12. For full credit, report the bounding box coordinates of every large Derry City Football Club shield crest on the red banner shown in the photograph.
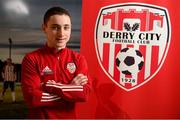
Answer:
[94,3,171,91]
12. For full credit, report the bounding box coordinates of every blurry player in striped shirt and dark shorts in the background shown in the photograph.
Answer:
[1,58,16,102]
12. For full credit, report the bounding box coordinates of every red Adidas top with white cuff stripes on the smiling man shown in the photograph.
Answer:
[22,45,91,119]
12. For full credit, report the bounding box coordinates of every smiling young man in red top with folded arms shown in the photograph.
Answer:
[22,7,91,119]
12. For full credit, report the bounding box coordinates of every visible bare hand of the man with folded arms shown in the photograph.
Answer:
[70,74,88,86]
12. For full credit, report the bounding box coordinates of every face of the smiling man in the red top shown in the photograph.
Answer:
[43,15,71,50]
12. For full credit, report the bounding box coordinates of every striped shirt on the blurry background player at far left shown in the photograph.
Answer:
[2,65,16,81]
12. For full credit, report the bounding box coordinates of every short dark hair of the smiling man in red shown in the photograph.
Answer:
[43,7,71,25]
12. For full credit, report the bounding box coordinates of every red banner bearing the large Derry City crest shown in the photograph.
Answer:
[77,0,180,118]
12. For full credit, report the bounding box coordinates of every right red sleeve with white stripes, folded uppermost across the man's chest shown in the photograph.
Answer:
[43,57,92,101]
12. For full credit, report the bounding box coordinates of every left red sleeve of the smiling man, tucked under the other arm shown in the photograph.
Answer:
[21,56,61,107]
